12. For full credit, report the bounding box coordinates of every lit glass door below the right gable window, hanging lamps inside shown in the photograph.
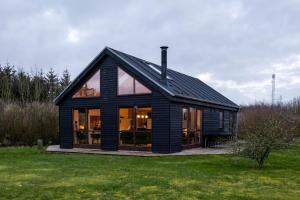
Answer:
[119,107,152,148]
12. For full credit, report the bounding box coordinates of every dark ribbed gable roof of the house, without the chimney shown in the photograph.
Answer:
[54,47,239,109]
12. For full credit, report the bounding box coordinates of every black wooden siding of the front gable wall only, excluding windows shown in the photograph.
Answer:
[59,57,170,153]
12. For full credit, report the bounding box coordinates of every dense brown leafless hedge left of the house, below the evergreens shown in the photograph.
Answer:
[0,102,58,146]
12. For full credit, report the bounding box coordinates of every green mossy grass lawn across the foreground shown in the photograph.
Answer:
[0,139,300,199]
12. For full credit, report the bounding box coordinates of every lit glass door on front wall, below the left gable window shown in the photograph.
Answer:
[73,108,101,144]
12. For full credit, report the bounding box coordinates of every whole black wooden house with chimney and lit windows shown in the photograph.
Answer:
[55,47,239,153]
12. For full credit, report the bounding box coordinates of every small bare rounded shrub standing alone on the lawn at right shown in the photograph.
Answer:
[238,106,292,168]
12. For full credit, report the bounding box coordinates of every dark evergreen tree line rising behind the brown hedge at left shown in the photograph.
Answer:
[0,63,71,103]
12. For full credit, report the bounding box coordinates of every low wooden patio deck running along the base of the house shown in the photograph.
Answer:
[46,145,232,157]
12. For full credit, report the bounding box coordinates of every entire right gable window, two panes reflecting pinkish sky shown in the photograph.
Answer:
[118,67,151,95]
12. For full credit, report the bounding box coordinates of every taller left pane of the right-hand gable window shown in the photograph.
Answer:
[118,68,134,95]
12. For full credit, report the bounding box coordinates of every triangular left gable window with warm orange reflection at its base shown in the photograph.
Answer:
[73,70,100,98]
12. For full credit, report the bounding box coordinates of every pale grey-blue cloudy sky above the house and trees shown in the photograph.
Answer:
[0,0,300,104]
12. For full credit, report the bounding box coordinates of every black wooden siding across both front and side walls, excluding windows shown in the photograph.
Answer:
[59,56,236,153]
